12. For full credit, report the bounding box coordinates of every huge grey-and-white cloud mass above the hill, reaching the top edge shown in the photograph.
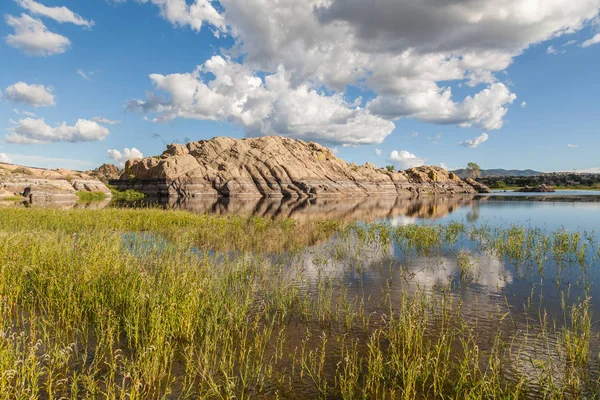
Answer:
[128,0,599,144]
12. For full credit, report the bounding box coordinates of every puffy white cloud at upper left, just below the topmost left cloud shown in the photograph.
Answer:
[5,14,71,56]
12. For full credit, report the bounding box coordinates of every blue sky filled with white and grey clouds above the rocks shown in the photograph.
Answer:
[0,0,600,173]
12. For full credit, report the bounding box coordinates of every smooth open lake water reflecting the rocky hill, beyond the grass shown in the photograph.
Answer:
[112,191,600,231]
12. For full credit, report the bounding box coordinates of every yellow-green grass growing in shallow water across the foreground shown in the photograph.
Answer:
[0,209,600,399]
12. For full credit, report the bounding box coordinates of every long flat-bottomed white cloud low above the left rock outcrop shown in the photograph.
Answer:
[4,118,110,144]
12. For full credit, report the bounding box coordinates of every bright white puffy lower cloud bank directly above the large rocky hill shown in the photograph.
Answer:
[127,56,395,145]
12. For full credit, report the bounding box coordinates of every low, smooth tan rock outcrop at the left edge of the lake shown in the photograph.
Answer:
[0,163,111,203]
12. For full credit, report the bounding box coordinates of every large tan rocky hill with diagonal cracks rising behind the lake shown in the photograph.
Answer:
[110,136,488,197]
